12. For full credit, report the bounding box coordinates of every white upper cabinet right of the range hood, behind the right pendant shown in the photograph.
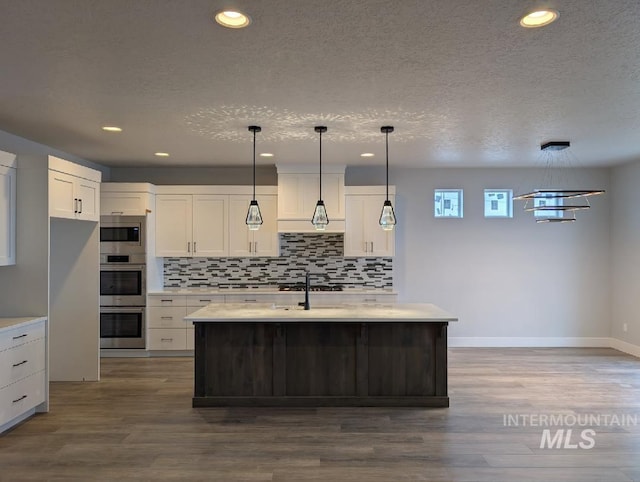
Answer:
[344,186,395,257]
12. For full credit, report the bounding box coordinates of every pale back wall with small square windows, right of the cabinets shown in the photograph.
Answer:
[347,168,611,338]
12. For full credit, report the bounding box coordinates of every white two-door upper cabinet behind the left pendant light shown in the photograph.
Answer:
[229,195,279,257]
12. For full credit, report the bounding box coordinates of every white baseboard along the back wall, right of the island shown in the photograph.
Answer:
[448,336,612,348]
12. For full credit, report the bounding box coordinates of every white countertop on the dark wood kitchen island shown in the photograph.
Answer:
[185,303,458,323]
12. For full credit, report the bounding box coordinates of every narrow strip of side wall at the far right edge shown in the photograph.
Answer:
[611,163,640,347]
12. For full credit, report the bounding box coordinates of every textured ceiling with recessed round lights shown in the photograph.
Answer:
[0,0,640,167]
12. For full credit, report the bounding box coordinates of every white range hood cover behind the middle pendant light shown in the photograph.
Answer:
[278,165,345,233]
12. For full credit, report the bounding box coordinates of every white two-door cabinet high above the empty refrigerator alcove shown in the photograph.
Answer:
[49,156,102,221]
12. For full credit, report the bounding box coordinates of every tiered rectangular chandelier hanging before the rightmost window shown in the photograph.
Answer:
[513,141,604,223]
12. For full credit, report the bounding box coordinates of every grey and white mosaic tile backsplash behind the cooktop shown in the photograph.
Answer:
[164,233,393,288]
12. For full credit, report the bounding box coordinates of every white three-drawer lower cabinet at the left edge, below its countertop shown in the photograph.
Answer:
[0,320,47,432]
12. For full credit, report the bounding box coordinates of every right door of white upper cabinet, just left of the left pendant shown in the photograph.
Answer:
[192,194,229,257]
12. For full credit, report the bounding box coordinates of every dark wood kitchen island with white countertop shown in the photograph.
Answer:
[185,303,457,407]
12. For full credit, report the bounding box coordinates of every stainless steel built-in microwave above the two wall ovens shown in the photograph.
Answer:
[100,216,147,254]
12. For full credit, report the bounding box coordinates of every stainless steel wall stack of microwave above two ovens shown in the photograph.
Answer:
[100,216,147,348]
